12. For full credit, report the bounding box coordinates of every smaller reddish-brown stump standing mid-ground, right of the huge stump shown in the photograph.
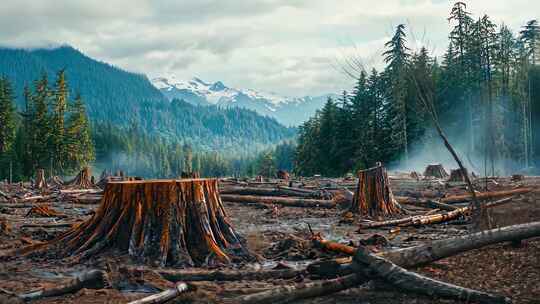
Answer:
[350,163,402,217]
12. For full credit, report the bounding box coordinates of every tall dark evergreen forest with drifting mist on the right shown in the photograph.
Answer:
[295,2,540,176]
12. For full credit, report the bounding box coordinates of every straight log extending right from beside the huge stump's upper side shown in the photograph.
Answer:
[221,194,336,208]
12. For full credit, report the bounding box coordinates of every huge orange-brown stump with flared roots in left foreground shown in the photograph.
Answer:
[22,179,252,266]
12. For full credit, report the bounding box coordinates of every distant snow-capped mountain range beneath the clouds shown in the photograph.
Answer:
[152,77,333,126]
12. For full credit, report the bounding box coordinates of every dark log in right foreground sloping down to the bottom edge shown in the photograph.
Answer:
[352,247,511,304]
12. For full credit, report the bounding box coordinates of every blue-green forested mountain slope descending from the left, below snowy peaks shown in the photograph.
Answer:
[0,46,294,151]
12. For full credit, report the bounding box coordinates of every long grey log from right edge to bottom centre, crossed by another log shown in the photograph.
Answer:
[249,222,540,304]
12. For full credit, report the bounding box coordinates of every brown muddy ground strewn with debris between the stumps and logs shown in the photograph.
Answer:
[0,178,540,304]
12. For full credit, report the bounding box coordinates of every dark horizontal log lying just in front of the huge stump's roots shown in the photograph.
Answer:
[154,268,306,282]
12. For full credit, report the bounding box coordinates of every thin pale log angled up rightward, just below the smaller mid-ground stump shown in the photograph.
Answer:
[360,197,513,229]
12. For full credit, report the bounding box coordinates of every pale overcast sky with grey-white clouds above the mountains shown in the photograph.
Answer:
[0,0,540,96]
